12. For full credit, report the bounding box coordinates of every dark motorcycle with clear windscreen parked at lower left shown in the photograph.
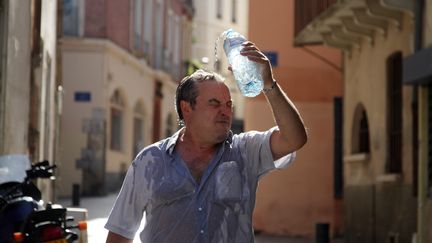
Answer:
[0,155,87,243]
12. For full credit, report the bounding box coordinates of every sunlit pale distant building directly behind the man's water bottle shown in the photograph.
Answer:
[192,0,249,133]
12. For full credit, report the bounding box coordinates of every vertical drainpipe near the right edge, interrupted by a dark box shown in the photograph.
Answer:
[413,0,428,243]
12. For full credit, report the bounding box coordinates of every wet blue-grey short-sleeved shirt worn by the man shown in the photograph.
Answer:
[105,127,295,243]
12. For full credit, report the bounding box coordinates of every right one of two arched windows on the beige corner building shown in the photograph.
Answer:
[132,102,145,156]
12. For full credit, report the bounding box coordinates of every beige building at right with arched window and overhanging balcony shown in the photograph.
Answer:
[295,0,420,242]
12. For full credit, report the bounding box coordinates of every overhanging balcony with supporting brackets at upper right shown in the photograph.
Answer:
[294,0,414,53]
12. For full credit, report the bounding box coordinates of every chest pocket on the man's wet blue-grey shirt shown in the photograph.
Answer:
[215,161,242,203]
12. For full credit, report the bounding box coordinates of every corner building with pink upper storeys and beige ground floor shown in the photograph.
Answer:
[58,0,194,196]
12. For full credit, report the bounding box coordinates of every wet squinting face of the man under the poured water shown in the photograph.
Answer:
[186,80,233,143]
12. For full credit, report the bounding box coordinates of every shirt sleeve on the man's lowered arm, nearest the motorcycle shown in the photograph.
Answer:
[105,161,146,239]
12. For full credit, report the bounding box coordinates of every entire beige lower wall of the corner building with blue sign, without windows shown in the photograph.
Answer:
[58,38,162,196]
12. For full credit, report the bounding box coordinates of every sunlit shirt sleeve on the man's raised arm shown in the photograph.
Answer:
[238,127,296,178]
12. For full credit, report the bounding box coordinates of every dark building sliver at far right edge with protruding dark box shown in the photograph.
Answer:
[403,0,432,243]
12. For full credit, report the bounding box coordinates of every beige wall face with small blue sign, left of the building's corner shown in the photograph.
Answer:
[56,39,104,196]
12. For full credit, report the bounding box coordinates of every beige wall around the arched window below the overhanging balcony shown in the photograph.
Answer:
[344,13,413,185]
